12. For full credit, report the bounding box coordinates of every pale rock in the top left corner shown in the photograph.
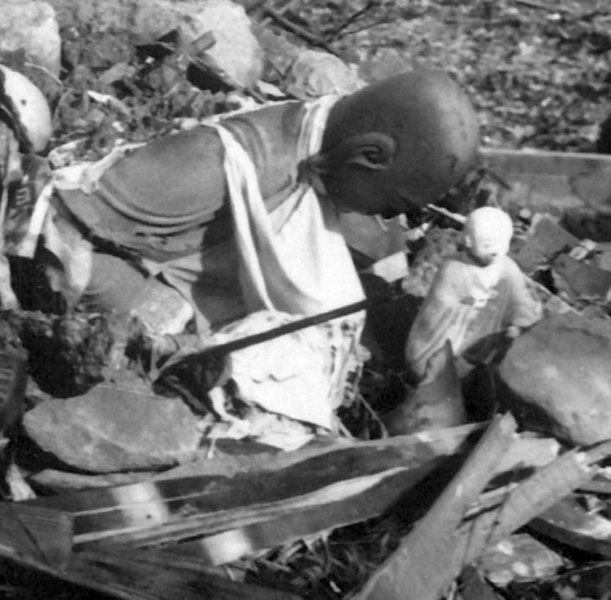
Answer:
[0,0,61,77]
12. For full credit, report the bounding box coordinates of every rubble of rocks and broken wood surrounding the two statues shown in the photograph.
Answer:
[0,0,611,600]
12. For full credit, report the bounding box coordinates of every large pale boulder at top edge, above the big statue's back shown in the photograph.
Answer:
[45,0,263,86]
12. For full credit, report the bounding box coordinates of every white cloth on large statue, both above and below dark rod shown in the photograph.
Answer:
[206,98,364,428]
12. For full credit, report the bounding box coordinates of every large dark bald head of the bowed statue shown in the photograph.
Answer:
[317,71,479,217]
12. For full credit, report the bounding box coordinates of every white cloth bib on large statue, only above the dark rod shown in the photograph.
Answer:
[213,97,364,315]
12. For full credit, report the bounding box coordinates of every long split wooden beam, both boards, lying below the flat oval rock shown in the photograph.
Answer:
[23,426,486,547]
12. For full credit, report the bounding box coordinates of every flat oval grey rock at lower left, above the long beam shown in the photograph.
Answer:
[24,385,201,473]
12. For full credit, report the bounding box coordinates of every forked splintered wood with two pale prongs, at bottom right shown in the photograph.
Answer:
[357,426,611,600]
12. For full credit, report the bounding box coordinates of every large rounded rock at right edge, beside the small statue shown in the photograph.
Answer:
[499,314,611,445]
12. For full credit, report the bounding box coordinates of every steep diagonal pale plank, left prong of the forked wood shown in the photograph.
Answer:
[357,414,517,600]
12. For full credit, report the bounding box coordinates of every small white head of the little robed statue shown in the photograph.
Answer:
[464,206,513,267]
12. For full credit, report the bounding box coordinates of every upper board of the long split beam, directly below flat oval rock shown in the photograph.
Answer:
[26,426,480,542]
